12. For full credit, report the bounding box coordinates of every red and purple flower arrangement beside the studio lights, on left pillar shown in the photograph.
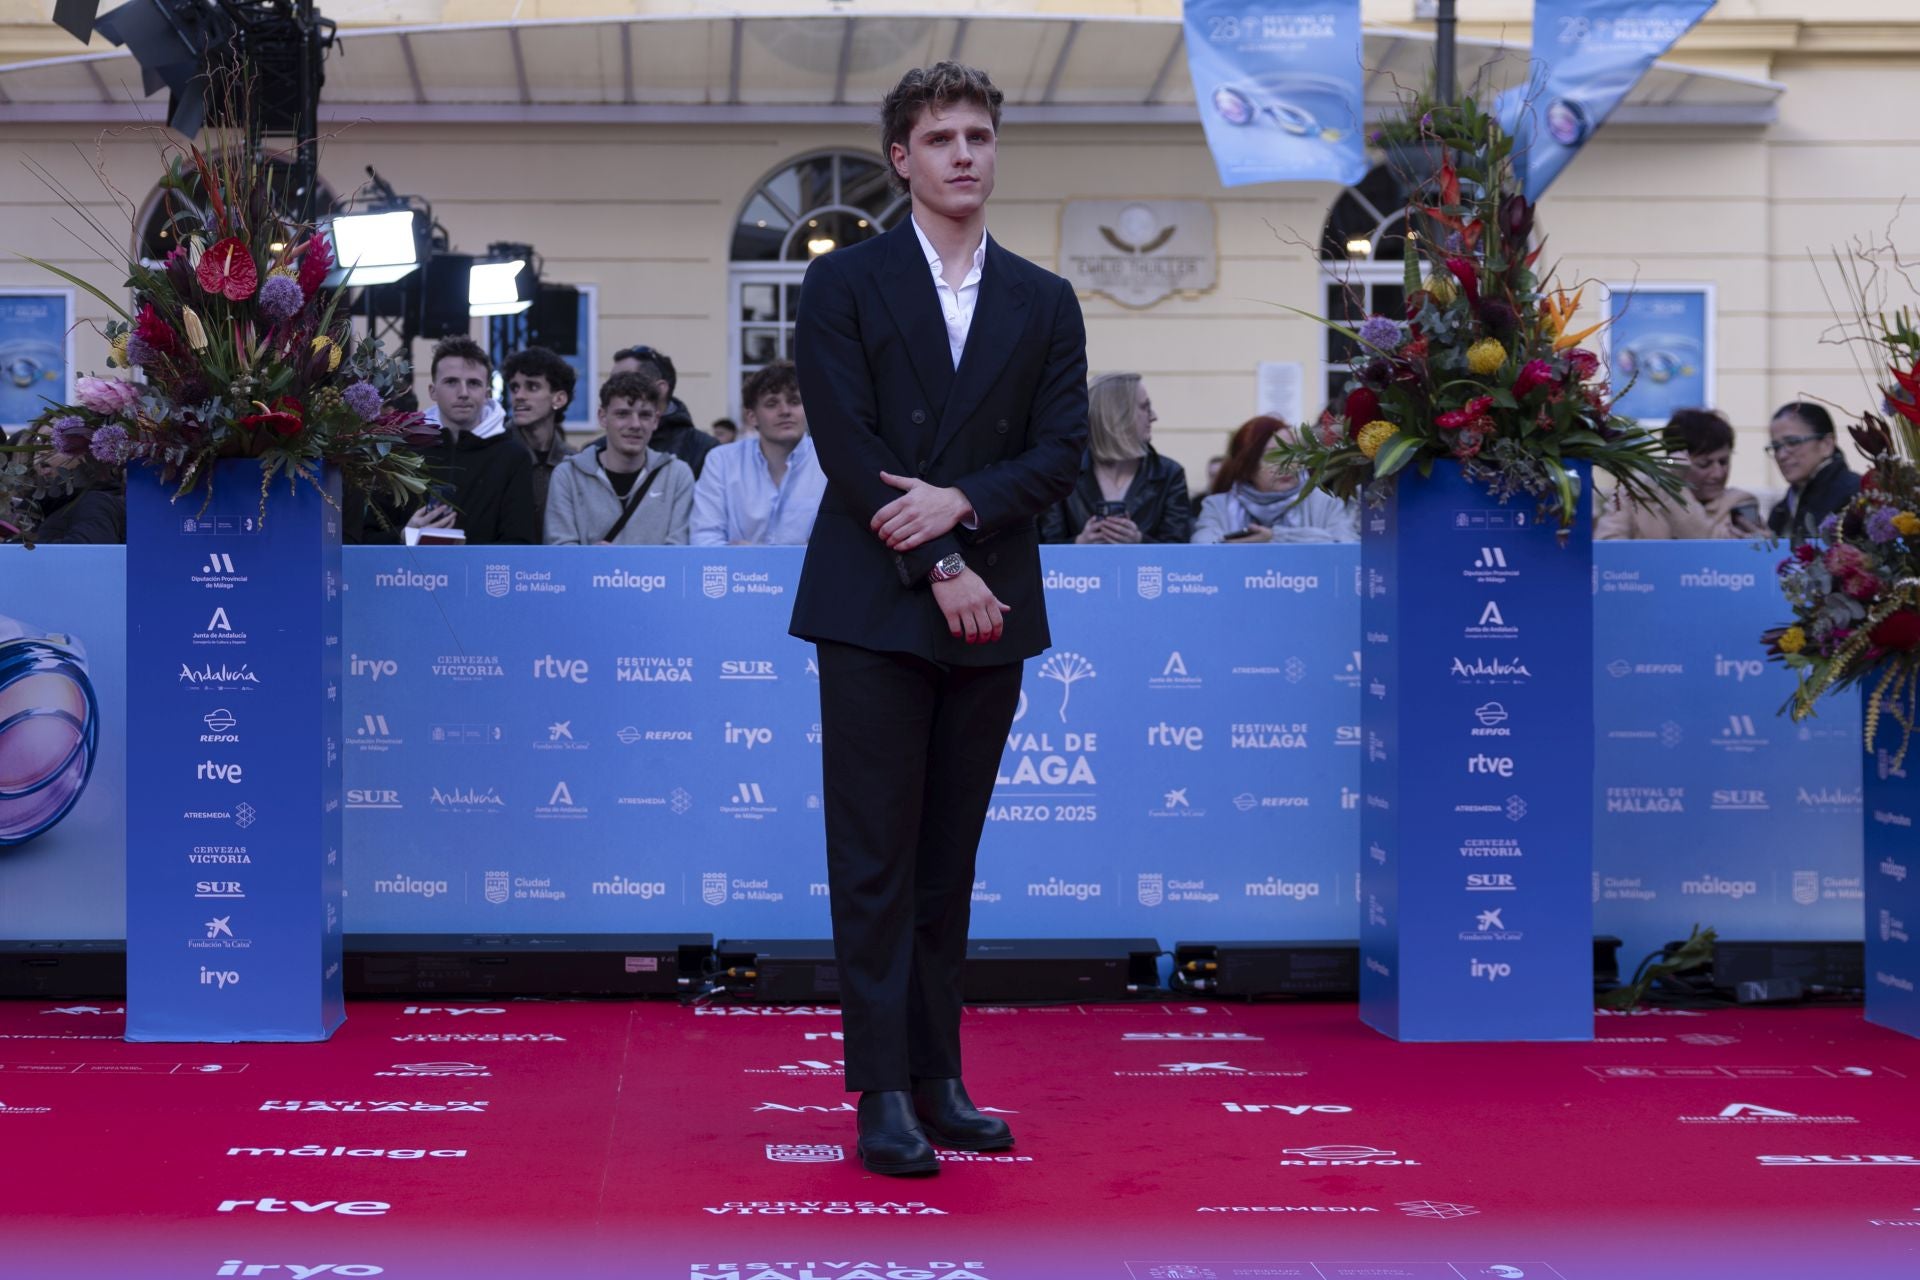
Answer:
[0,131,436,520]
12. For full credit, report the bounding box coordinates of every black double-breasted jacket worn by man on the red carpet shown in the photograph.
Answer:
[791,219,1087,666]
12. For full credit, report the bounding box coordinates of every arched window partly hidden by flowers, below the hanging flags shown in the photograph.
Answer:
[1308,165,1407,413]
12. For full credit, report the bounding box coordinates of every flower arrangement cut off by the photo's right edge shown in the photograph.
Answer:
[1761,289,1920,768]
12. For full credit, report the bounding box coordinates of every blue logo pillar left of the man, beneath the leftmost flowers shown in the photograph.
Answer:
[127,461,346,1042]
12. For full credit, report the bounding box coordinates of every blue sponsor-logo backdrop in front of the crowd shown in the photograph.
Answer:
[0,543,1862,961]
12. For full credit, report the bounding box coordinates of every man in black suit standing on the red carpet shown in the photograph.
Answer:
[791,61,1087,1174]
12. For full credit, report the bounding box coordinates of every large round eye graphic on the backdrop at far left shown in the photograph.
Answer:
[0,616,100,846]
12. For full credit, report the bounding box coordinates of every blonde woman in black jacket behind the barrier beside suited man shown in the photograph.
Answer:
[1041,374,1194,543]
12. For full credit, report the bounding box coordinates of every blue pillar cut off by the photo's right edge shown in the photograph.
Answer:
[1860,736,1920,1036]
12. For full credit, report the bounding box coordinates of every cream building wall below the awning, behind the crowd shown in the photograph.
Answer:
[11,45,1920,489]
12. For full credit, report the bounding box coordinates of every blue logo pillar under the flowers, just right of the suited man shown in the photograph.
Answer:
[1359,462,1594,1040]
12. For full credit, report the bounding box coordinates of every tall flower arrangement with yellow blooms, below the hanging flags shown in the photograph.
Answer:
[1275,98,1680,532]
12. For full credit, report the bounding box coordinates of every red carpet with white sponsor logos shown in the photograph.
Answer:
[0,1000,1920,1280]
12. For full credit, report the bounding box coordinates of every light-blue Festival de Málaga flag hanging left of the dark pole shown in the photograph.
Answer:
[1185,0,1367,186]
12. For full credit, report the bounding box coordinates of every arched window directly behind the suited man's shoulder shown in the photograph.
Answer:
[728,152,908,416]
